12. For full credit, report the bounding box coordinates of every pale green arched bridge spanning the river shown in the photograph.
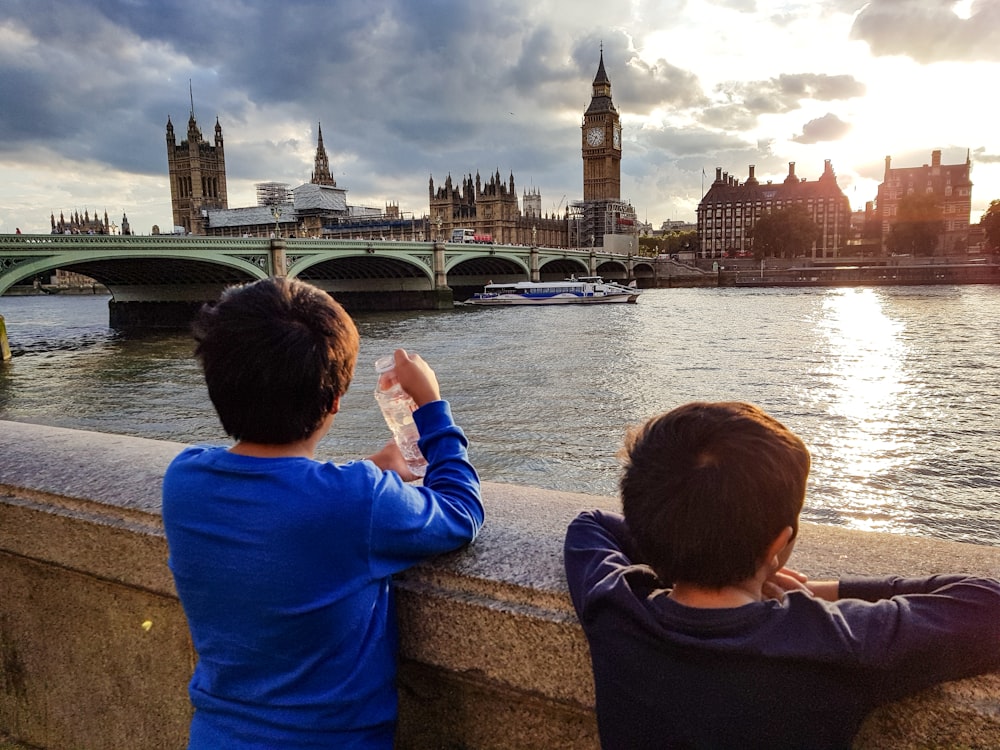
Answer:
[0,234,655,328]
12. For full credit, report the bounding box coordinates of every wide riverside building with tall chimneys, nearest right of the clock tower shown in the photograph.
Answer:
[698,159,851,258]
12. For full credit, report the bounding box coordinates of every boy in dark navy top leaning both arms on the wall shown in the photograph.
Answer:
[565,403,1000,750]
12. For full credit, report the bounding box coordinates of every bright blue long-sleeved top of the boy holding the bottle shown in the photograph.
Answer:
[163,401,483,750]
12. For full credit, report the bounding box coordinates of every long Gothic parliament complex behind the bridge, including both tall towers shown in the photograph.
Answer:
[166,50,638,252]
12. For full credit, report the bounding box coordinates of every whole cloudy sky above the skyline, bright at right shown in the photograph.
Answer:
[0,0,1000,234]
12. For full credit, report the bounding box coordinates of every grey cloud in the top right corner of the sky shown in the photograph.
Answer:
[851,0,1000,63]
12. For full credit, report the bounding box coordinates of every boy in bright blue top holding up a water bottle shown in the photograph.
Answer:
[163,278,483,750]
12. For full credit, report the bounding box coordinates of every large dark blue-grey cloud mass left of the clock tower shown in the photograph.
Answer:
[0,0,584,187]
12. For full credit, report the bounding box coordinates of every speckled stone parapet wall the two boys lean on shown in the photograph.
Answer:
[0,422,1000,750]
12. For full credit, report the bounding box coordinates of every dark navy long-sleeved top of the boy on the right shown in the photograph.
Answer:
[565,511,1000,750]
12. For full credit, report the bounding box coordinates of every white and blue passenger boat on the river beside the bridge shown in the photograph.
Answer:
[465,276,641,306]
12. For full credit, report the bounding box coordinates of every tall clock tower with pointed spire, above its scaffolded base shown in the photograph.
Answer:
[582,50,622,201]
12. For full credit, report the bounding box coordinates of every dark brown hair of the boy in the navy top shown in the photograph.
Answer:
[619,402,810,589]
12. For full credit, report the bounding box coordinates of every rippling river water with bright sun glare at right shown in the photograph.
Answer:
[0,286,1000,546]
